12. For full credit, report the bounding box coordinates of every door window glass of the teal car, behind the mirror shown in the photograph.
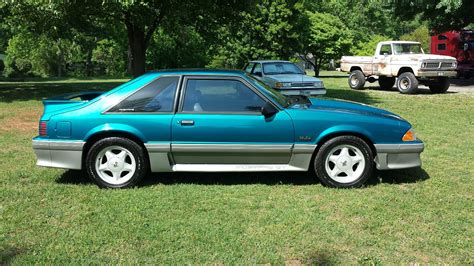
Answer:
[183,79,265,113]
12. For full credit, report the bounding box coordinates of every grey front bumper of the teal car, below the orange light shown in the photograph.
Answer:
[374,142,425,170]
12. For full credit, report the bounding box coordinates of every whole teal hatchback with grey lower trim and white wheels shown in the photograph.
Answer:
[33,70,424,188]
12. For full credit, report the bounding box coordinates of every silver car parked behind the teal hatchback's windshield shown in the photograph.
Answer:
[244,60,326,96]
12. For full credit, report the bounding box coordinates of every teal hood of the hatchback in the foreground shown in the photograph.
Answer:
[292,98,406,121]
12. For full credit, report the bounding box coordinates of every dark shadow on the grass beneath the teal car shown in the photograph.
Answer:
[56,168,430,187]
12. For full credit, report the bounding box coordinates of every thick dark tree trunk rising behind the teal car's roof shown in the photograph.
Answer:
[127,24,147,77]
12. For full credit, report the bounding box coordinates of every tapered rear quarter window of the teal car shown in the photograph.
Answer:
[109,77,179,113]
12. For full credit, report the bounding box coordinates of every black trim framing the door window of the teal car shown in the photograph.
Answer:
[176,75,281,115]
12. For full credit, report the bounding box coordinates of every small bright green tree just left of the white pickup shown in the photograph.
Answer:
[300,11,353,76]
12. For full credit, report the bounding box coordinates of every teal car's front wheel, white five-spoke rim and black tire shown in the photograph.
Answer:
[314,136,374,188]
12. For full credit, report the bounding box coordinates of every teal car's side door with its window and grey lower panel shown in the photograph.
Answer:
[171,76,294,164]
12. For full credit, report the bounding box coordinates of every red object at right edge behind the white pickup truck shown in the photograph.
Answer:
[431,30,474,78]
